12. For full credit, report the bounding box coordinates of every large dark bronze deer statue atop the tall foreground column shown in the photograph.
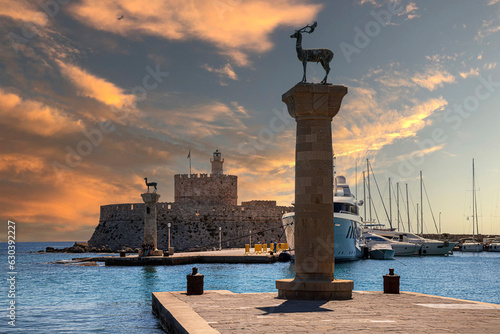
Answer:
[290,22,333,84]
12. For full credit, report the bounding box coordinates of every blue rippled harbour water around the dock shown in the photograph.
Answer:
[0,243,500,333]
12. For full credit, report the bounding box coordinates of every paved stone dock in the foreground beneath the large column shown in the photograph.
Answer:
[152,290,500,334]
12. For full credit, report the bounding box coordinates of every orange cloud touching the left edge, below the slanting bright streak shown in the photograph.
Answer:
[0,88,83,136]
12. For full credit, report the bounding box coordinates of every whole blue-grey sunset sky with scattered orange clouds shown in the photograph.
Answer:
[0,0,500,241]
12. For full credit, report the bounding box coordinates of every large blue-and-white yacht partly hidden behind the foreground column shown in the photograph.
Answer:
[282,176,363,262]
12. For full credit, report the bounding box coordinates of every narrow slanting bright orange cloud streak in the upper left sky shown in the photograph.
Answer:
[56,60,135,108]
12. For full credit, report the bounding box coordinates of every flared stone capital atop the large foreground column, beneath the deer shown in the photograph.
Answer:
[281,83,347,119]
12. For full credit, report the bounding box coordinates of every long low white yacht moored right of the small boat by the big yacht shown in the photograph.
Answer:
[370,230,457,255]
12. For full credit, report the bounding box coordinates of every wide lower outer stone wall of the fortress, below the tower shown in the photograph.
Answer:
[88,201,293,251]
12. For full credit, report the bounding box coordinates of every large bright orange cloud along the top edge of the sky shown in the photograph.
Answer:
[71,0,322,66]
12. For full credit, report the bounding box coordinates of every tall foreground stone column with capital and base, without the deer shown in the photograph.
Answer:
[276,84,354,300]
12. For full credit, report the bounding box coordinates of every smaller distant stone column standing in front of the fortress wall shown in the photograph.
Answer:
[139,193,163,256]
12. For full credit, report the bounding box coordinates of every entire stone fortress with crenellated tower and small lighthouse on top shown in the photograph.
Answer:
[88,150,293,251]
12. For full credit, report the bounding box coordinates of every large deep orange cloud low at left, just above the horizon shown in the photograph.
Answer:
[0,154,146,241]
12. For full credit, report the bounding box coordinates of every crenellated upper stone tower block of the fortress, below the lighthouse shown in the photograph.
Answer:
[174,174,238,205]
